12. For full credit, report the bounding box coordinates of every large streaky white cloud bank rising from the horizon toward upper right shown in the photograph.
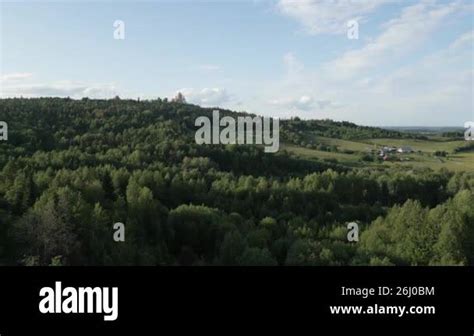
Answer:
[254,1,474,126]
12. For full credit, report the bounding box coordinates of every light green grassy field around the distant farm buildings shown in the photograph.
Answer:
[282,137,474,171]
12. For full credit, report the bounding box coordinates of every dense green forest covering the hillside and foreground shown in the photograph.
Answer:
[0,98,474,265]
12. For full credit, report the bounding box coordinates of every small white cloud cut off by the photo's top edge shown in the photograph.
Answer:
[277,0,387,34]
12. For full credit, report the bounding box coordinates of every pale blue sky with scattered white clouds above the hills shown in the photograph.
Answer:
[0,0,474,126]
